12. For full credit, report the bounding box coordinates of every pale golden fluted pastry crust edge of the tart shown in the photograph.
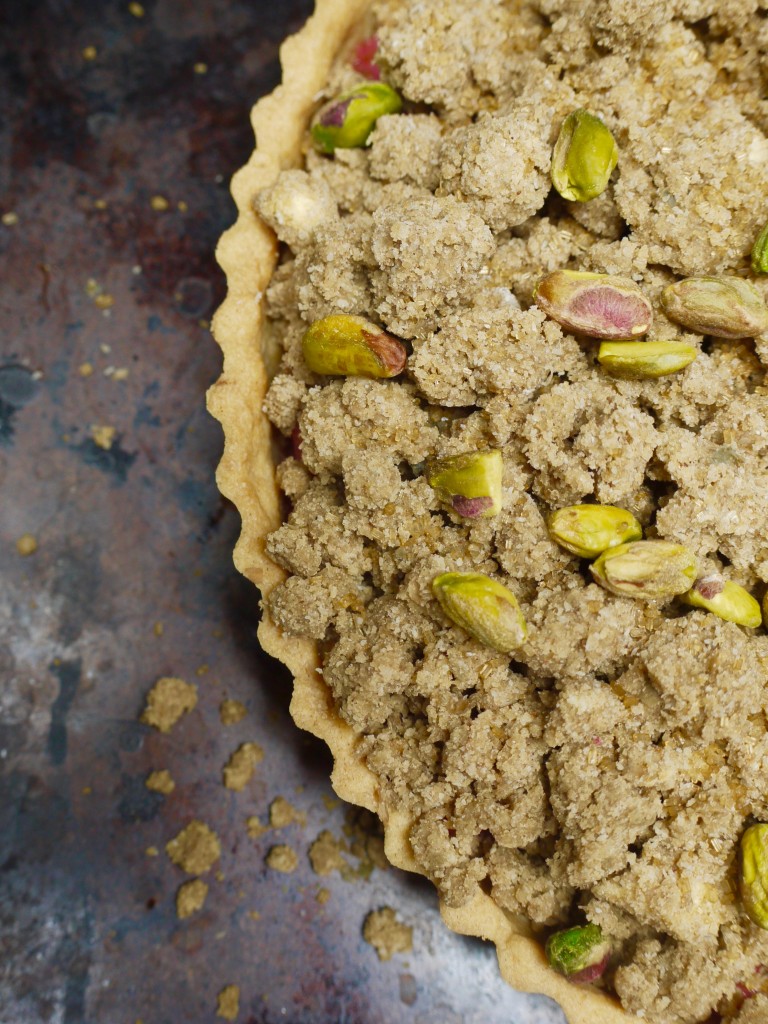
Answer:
[208,0,637,1024]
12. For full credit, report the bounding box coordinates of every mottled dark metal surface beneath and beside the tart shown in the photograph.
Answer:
[0,8,563,1024]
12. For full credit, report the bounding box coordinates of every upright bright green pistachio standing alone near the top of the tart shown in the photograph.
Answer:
[551,109,618,203]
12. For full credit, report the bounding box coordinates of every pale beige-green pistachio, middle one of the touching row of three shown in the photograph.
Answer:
[590,541,696,601]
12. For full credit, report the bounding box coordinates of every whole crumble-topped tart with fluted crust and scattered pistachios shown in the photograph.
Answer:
[209,0,768,1024]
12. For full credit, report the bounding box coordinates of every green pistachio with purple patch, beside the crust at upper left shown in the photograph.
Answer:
[311,82,402,153]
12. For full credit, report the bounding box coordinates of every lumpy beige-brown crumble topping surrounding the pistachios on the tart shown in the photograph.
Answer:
[256,0,768,1024]
